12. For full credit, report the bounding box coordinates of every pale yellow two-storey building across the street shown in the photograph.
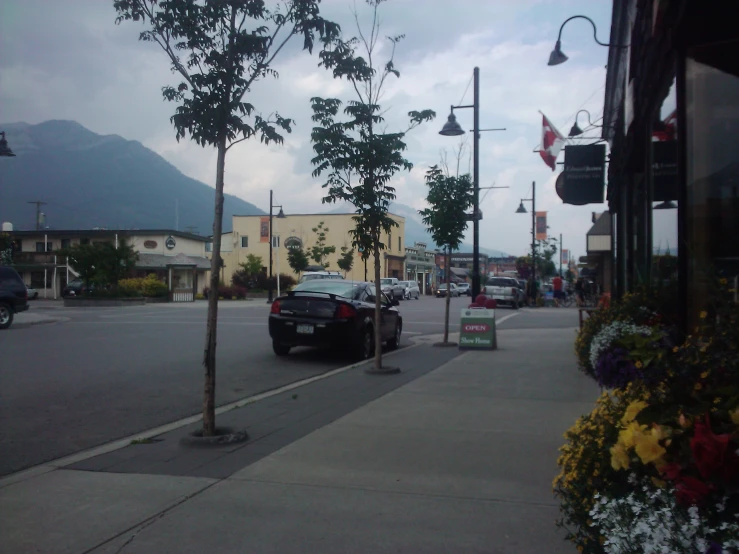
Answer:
[211,209,405,284]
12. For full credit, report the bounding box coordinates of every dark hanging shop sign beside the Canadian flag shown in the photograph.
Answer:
[555,144,606,206]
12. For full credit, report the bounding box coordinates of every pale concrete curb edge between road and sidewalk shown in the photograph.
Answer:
[0,342,424,489]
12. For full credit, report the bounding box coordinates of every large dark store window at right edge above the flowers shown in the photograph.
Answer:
[685,41,739,324]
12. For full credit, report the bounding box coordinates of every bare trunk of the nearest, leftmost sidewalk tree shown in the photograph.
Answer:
[203,134,226,437]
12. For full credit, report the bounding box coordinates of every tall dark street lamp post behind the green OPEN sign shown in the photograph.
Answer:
[439,67,505,298]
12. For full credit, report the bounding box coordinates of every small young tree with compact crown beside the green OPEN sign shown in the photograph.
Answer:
[418,166,474,345]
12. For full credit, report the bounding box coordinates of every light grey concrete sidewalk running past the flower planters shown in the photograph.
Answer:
[0,329,598,554]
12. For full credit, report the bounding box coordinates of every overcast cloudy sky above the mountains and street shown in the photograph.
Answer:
[0,0,636,256]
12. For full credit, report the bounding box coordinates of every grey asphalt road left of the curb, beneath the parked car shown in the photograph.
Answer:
[0,297,577,475]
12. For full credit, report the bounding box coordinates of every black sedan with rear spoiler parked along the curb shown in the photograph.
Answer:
[269,279,403,360]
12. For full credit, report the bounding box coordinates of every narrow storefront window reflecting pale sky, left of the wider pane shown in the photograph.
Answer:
[651,78,679,294]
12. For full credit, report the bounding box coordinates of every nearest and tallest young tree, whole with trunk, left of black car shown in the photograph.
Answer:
[113,0,339,436]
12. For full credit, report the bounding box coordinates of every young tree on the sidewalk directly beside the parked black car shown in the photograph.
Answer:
[311,0,436,372]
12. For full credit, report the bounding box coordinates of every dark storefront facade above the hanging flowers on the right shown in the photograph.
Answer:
[603,0,739,328]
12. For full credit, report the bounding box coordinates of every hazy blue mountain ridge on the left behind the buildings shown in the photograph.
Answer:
[0,121,264,235]
